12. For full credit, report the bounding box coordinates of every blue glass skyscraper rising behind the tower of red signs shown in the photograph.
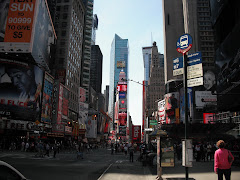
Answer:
[108,34,129,126]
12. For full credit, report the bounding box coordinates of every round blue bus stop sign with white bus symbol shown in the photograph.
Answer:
[177,34,192,54]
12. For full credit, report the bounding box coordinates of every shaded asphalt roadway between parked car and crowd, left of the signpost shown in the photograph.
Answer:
[0,149,154,180]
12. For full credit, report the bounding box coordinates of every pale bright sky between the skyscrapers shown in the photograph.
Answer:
[93,0,164,125]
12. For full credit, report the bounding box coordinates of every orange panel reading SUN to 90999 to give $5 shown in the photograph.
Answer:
[1,0,36,43]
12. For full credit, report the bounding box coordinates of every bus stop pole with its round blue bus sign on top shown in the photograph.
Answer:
[177,34,192,180]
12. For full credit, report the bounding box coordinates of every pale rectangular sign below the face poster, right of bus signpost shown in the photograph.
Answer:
[195,91,217,108]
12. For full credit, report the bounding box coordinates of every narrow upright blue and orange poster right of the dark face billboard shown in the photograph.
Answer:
[41,72,54,123]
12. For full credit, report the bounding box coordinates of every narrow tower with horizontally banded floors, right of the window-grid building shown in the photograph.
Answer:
[81,0,94,101]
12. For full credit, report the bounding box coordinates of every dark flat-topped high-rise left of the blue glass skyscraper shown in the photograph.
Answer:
[90,45,103,93]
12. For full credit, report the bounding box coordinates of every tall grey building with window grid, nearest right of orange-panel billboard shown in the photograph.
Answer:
[50,0,85,118]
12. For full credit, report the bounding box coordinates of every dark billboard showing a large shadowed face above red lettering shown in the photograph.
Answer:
[0,59,43,121]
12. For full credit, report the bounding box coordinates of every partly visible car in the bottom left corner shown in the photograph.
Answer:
[0,161,27,180]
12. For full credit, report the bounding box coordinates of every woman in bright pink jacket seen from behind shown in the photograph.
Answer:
[214,140,234,180]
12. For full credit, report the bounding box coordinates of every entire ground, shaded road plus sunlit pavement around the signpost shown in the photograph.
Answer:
[0,148,240,180]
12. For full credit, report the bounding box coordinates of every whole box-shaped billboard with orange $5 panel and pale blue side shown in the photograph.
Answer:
[0,0,56,69]
